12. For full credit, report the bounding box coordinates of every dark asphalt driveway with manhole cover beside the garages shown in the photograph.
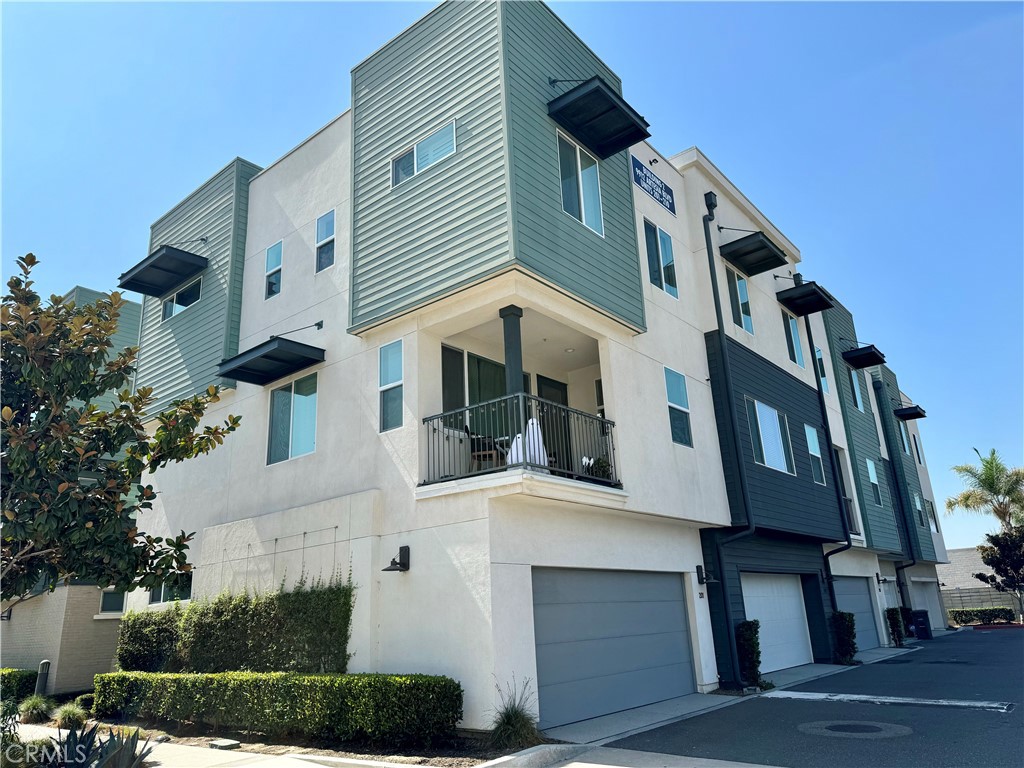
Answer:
[607,630,1024,768]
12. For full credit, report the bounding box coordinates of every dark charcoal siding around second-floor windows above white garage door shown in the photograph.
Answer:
[705,332,843,541]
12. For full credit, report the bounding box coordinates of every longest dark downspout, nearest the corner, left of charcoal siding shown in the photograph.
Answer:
[703,191,756,684]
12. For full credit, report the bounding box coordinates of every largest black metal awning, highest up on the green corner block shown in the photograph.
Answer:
[548,77,650,160]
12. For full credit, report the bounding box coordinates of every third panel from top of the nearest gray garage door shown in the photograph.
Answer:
[537,632,689,684]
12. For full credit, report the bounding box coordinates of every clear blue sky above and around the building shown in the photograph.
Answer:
[2,2,1024,547]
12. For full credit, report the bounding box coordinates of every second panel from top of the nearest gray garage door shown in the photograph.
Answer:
[534,602,686,643]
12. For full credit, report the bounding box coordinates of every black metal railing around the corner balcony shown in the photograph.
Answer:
[423,394,622,487]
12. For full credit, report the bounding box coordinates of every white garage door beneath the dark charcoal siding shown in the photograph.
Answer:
[740,573,814,673]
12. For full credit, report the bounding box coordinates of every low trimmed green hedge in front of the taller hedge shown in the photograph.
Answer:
[94,672,462,746]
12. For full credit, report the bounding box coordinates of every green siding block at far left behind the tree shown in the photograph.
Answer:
[135,159,260,414]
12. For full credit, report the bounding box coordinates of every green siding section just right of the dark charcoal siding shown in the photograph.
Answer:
[822,302,902,553]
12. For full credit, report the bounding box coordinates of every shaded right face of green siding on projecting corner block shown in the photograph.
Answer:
[501,2,643,329]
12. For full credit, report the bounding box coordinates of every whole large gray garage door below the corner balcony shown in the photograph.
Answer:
[534,568,696,728]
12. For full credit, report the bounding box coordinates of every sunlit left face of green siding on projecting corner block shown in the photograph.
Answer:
[351,2,510,331]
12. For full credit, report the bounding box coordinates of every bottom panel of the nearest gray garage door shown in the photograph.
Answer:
[538,664,693,728]
